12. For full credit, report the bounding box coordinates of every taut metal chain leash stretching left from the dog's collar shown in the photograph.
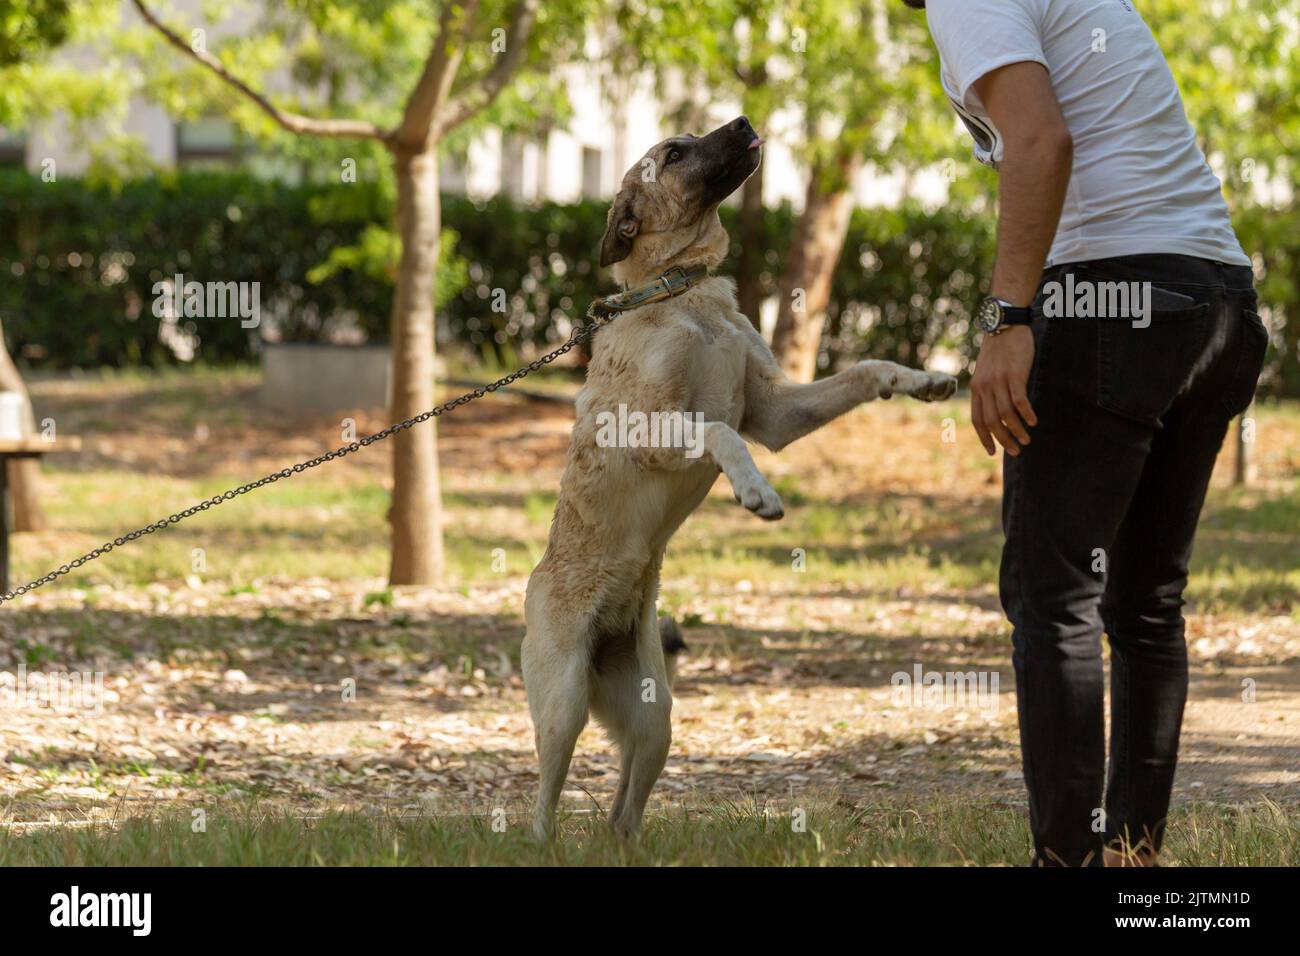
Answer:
[0,311,618,605]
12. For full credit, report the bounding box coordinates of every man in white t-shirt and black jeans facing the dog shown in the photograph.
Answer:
[905,0,1268,866]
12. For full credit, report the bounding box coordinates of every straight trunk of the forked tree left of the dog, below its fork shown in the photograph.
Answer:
[389,147,443,584]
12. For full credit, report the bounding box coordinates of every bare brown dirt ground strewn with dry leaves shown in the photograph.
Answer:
[0,385,1300,822]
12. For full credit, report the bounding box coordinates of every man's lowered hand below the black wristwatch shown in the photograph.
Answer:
[971,325,1039,455]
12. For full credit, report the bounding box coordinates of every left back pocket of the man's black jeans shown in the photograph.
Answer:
[1097,302,1210,425]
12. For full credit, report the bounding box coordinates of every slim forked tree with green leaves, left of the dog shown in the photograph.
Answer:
[125,0,581,584]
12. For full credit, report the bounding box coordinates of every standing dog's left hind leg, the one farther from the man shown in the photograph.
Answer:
[521,633,590,839]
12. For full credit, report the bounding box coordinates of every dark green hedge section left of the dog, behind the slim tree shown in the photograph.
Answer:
[0,172,610,368]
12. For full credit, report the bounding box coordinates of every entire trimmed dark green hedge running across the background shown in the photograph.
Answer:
[0,170,1300,394]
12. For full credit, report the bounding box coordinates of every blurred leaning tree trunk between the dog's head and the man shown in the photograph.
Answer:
[772,159,854,381]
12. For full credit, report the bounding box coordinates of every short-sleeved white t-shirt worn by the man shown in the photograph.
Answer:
[926,0,1251,265]
